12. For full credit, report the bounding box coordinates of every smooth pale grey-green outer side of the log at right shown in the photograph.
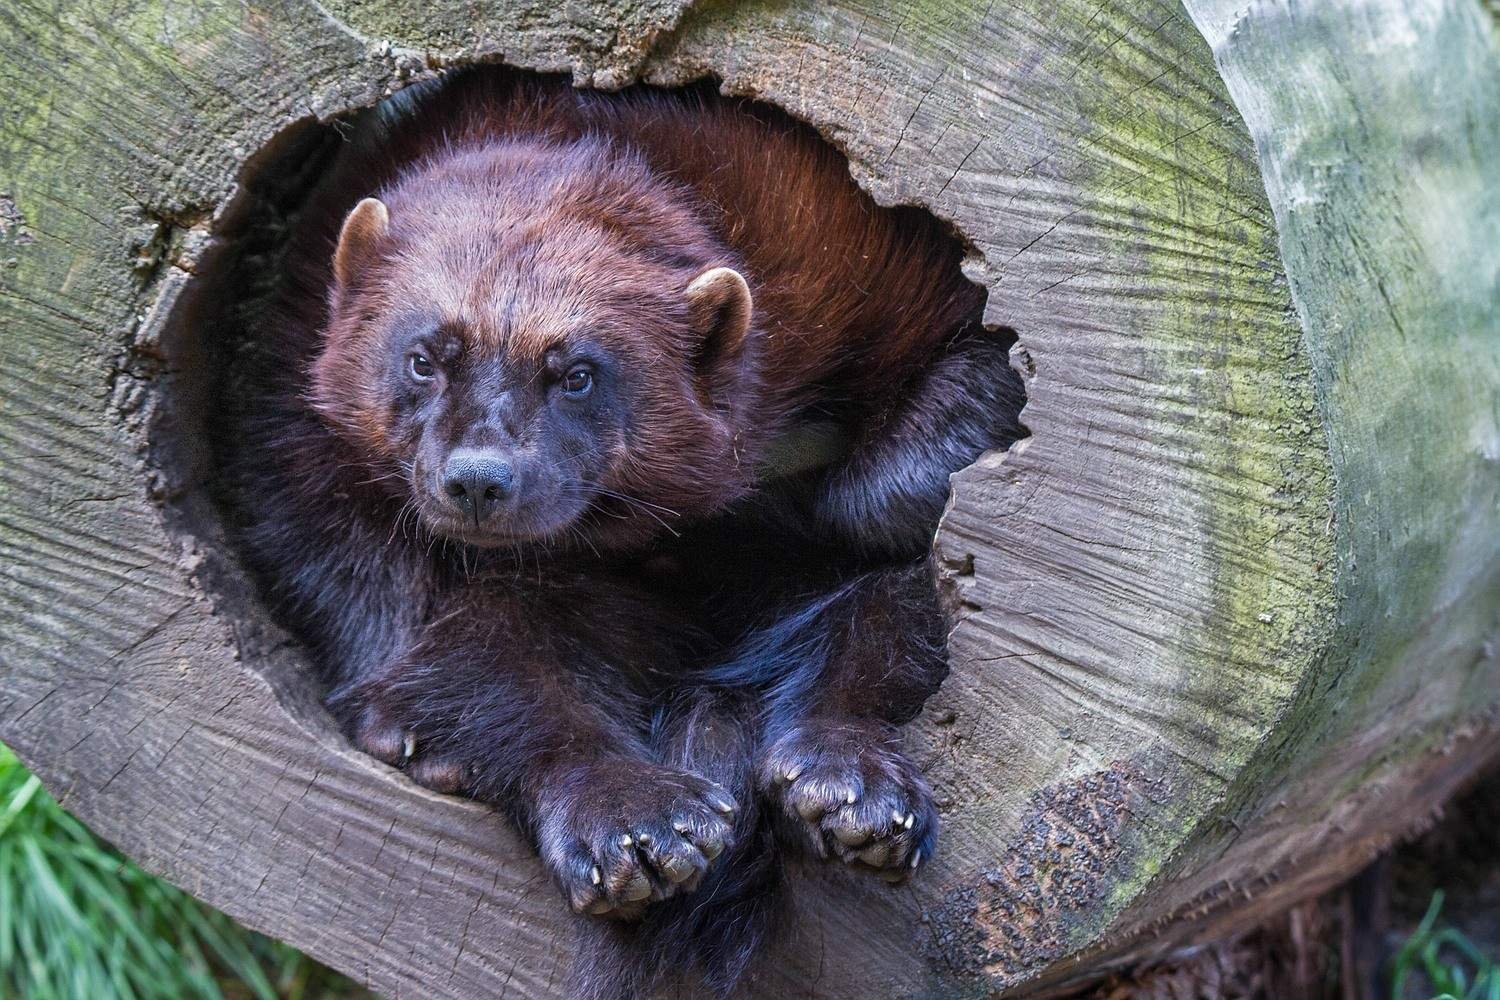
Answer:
[1188,0,1500,803]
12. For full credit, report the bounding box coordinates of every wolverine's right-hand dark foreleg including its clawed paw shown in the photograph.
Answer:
[723,561,947,880]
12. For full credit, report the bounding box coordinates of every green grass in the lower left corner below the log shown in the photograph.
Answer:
[0,747,369,1000]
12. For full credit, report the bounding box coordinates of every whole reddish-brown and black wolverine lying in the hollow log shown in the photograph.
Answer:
[221,69,1022,999]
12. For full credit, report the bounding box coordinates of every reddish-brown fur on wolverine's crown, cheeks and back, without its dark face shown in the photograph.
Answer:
[312,75,981,544]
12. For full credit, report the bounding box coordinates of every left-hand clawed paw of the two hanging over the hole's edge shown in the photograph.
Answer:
[539,760,740,919]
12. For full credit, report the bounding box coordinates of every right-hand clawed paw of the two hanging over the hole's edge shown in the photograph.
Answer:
[759,718,938,883]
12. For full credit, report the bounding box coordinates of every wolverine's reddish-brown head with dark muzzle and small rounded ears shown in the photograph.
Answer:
[311,141,755,547]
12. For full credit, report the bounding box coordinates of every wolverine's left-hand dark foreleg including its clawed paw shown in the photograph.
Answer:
[333,580,738,918]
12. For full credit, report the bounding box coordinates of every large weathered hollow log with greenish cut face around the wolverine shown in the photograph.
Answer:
[0,0,1500,999]
